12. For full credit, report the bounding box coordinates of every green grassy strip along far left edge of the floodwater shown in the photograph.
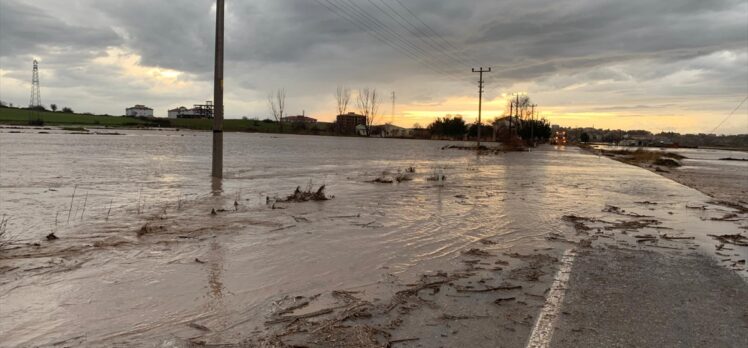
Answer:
[0,108,331,134]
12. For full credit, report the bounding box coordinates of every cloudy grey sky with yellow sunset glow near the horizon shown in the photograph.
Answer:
[0,0,748,133]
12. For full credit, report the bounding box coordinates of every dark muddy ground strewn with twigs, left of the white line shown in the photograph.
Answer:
[240,248,558,348]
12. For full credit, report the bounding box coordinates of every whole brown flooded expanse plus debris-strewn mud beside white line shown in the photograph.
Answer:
[0,130,748,347]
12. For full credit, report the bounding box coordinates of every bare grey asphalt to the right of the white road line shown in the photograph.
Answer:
[551,249,748,347]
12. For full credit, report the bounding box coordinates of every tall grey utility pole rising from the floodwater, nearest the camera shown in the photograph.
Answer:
[212,0,224,179]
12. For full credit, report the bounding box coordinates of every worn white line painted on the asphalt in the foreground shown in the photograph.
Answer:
[527,249,577,348]
